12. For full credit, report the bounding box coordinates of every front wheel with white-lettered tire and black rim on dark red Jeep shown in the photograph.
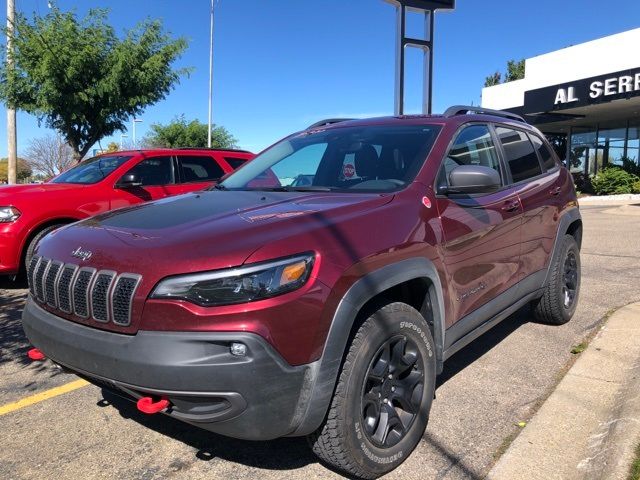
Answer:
[308,303,436,479]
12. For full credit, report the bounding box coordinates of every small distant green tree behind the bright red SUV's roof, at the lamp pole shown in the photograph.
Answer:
[144,115,237,148]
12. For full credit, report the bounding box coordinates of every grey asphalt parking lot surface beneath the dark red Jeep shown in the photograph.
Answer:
[0,206,640,480]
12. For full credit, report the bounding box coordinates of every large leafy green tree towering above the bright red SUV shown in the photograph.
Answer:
[0,8,188,160]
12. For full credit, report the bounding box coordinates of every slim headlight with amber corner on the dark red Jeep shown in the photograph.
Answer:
[151,254,314,307]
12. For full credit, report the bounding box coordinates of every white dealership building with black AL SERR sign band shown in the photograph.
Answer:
[482,28,640,175]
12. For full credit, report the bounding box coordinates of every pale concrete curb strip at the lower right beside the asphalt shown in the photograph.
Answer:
[486,302,640,480]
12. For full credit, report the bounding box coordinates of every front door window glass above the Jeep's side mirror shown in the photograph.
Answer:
[439,125,502,185]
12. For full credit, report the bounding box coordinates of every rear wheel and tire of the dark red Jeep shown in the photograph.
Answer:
[532,235,581,325]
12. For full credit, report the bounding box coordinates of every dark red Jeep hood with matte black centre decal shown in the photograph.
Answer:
[38,191,393,281]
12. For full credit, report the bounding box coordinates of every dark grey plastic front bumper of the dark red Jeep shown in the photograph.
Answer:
[22,298,315,440]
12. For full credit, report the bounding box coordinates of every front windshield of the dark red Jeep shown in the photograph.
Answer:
[217,125,440,192]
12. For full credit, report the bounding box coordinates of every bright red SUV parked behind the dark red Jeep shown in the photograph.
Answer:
[0,149,253,275]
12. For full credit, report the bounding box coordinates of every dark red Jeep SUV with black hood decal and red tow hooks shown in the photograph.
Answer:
[23,107,582,478]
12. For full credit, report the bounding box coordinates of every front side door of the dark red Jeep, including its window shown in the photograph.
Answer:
[436,124,522,327]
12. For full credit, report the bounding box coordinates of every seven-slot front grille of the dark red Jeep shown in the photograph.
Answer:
[27,256,142,327]
